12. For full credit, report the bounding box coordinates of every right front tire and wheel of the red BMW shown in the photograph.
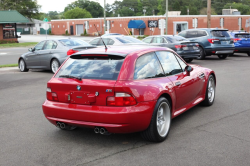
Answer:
[201,75,216,106]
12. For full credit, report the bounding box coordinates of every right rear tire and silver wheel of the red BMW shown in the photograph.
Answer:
[141,97,172,142]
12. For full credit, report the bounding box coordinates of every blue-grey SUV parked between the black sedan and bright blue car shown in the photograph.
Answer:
[178,28,234,59]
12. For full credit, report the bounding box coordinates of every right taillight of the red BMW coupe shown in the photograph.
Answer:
[107,93,136,106]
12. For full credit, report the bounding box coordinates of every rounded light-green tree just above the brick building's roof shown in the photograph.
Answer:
[64,7,92,19]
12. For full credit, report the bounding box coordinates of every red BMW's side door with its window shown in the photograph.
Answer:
[156,51,200,111]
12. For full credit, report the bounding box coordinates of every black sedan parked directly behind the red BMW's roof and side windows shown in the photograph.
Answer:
[143,35,200,62]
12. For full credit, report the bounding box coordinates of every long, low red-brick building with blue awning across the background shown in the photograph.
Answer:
[51,15,250,35]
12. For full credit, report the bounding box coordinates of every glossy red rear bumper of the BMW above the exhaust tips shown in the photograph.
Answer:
[42,100,156,133]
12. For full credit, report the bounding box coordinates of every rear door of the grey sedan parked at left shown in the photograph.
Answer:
[39,40,57,69]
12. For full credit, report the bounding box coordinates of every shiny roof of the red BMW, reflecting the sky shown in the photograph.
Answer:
[74,45,170,57]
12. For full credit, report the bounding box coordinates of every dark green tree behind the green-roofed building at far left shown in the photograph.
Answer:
[0,0,41,18]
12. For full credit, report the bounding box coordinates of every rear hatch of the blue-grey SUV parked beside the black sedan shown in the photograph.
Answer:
[208,29,234,47]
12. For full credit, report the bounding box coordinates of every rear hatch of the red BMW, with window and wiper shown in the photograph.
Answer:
[47,54,124,106]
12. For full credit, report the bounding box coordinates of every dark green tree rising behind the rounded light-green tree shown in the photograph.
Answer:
[64,0,104,18]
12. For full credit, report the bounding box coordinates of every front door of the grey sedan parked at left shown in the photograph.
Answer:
[25,41,46,68]
